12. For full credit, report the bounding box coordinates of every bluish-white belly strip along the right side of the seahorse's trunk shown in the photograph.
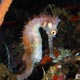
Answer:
[32,27,42,62]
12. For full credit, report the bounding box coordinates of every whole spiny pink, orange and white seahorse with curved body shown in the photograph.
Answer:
[17,15,60,80]
